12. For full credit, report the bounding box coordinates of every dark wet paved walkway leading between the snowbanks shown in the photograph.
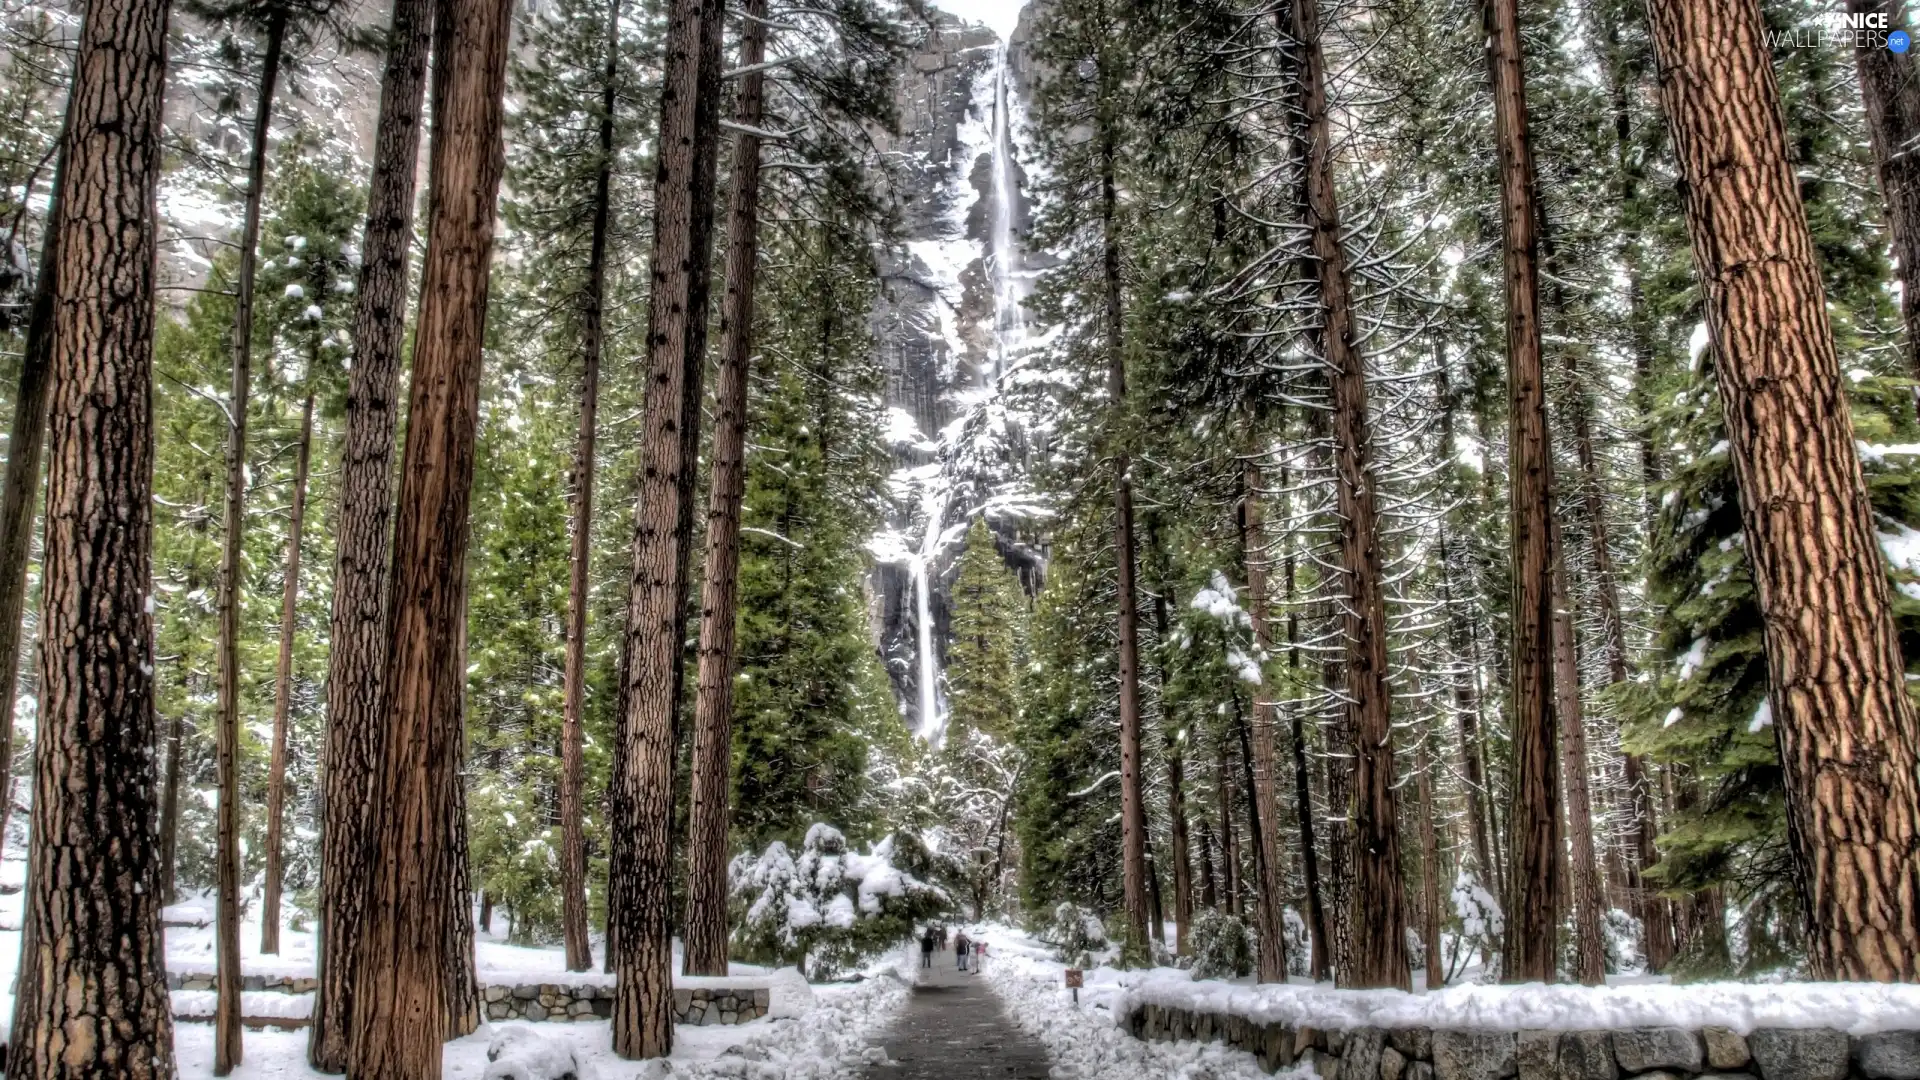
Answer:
[868,951,1046,1080]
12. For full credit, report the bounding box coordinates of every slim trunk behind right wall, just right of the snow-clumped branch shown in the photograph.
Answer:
[1240,457,1286,982]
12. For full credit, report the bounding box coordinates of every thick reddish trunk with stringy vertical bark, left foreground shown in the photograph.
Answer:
[348,0,513,1060]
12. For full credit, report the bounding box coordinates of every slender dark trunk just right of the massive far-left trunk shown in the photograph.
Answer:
[213,18,286,1076]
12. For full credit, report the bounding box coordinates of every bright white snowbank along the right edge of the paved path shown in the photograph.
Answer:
[966,924,1313,1080]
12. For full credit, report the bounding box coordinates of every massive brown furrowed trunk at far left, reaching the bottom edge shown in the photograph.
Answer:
[6,0,175,1060]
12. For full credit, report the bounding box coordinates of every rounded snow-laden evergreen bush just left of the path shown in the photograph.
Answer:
[730,824,950,982]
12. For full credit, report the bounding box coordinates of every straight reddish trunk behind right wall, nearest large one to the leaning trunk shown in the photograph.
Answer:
[1486,0,1563,982]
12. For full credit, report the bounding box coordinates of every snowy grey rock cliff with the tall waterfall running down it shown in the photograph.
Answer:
[870,6,1046,740]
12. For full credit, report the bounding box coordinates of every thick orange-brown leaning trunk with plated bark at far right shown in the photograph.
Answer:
[1649,0,1920,982]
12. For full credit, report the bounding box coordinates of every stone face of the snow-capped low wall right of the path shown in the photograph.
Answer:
[1123,1005,1920,1080]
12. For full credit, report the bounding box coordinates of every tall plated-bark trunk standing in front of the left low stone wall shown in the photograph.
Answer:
[609,0,724,1059]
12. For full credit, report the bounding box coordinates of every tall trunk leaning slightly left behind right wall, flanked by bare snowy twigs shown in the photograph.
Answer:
[1292,0,1409,990]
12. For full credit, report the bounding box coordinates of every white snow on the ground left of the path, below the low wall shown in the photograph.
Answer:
[173,949,916,1080]
